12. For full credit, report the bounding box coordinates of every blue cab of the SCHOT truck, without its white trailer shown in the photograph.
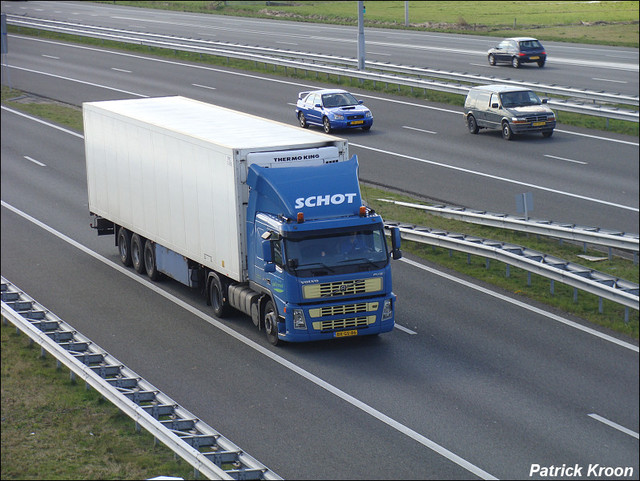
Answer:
[247,155,400,344]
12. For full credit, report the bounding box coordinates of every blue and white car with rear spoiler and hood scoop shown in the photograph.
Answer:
[296,89,373,134]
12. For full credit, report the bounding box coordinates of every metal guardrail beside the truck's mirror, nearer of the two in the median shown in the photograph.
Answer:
[385,221,639,312]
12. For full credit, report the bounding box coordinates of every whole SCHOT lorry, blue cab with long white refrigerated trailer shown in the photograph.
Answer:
[83,97,401,345]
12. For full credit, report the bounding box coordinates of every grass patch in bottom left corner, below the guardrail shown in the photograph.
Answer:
[1,318,195,479]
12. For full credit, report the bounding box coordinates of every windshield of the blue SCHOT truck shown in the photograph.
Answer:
[284,227,389,277]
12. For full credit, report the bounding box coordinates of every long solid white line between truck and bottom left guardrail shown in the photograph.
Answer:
[1,200,498,479]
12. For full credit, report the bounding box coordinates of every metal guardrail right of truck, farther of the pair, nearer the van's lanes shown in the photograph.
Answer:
[378,199,639,255]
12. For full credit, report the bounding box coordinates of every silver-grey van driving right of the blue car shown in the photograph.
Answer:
[464,85,556,140]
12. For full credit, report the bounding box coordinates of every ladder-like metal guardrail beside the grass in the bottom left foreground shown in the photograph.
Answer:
[1,277,282,480]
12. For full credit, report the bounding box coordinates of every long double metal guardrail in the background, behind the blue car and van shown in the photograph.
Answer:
[7,15,639,122]
